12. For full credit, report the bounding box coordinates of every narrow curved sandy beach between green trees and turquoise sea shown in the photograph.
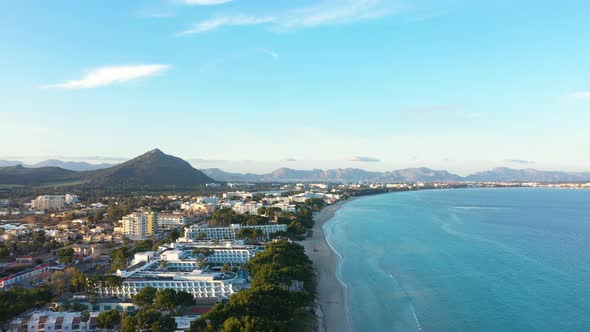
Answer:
[299,200,350,332]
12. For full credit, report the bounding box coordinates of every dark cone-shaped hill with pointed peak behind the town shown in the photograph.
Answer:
[85,149,215,186]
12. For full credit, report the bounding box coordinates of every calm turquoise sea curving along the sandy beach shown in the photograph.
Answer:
[324,188,590,332]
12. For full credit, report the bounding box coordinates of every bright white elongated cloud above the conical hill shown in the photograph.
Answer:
[46,64,170,89]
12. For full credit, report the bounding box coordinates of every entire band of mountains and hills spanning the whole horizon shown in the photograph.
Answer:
[0,149,590,187]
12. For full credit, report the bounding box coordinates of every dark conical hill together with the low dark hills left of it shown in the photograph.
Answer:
[0,149,215,188]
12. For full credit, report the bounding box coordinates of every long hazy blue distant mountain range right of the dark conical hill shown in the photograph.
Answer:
[203,167,590,183]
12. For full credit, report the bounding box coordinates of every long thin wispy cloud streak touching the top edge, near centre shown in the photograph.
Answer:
[180,0,400,35]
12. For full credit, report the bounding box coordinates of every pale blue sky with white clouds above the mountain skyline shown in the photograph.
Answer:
[0,0,590,174]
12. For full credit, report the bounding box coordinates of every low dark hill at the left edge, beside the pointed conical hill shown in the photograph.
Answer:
[0,165,76,185]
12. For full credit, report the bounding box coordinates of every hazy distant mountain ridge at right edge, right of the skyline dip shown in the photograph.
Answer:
[465,167,590,182]
